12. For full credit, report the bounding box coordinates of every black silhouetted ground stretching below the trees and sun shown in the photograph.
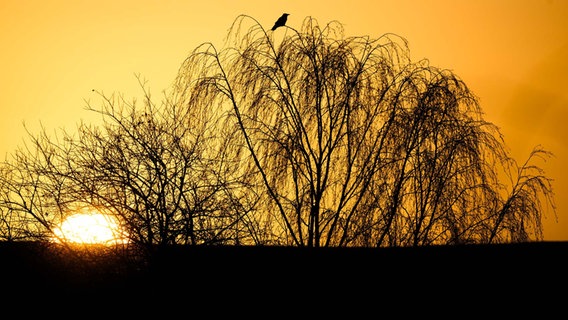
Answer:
[0,242,568,318]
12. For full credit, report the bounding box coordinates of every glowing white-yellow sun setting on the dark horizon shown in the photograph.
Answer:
[54,213,125,245]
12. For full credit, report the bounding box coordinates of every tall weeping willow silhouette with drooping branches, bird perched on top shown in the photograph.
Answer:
[176,15,554,247]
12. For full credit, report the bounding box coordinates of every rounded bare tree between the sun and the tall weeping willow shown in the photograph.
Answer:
[69,75,266,250]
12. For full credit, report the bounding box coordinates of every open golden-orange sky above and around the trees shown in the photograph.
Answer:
[0,0,568,241]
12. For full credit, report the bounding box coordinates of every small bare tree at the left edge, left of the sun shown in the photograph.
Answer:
[0,125,72,240]
